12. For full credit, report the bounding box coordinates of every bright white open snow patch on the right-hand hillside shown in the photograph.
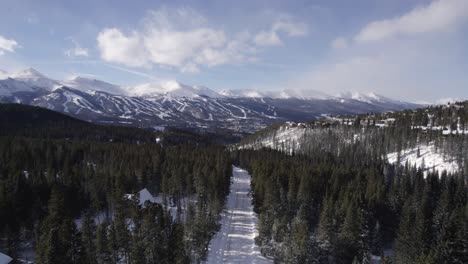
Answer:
[387,144,460,175]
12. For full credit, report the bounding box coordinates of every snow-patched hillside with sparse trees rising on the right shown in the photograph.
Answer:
[239,102,468,173]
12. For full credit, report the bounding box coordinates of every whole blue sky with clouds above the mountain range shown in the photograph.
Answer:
[0,0,468,101]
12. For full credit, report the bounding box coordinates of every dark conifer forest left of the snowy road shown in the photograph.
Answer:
[0,102,231,263]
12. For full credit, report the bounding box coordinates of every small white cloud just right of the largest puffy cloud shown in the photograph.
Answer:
[254,15,307,46]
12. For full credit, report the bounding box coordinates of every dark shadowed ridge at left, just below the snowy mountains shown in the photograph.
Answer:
[0,104,243,145]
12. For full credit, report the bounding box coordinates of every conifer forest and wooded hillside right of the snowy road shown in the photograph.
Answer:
[233,100,468,263]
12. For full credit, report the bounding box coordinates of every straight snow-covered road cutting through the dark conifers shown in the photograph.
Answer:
[206,167,273,264]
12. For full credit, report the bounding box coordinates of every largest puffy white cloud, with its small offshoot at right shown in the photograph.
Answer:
[97,8,306,73]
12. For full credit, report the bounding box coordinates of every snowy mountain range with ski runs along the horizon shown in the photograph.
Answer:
[0,69,419,132]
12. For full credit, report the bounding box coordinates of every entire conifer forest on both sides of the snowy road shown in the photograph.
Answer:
[0,102,468,264]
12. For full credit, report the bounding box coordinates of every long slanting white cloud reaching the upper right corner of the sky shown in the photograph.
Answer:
[354,0,468,42]
